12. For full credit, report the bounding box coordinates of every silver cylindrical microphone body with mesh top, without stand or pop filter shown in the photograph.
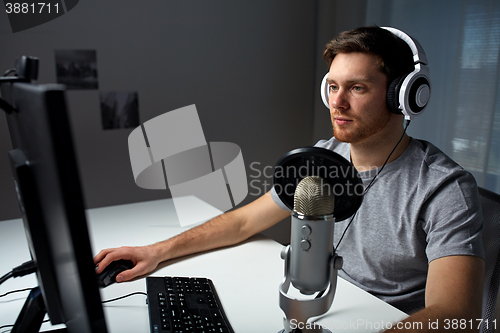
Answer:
[290,176,335,295]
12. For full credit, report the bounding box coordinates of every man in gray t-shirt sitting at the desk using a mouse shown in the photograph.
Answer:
[95,27,484,332]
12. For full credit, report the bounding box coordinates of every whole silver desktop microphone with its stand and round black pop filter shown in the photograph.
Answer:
[274,147,363,333]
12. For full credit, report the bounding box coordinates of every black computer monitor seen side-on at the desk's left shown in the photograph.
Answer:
[0,82,107,333]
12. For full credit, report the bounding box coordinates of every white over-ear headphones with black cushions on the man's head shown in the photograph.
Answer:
[321,27,431,120]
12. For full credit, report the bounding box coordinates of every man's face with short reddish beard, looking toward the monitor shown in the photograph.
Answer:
[327,52,392,144]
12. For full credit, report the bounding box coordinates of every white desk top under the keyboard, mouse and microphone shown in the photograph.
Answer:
[0,200,406,333]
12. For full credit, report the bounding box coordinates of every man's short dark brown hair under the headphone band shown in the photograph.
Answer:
[323,26,415,84]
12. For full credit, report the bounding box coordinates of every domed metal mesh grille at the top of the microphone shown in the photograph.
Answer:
[293,176,335,216]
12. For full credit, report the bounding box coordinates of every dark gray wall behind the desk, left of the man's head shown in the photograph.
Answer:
[0,0,328,244]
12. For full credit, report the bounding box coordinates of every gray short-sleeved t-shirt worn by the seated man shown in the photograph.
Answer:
[271,138,484,313]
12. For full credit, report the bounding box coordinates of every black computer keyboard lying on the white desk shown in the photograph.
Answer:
[146,276,234,333]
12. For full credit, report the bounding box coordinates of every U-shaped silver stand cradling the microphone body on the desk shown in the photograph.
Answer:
[280,245,343,333]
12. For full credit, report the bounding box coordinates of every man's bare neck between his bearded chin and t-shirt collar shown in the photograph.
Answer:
[351,131,411,172]
